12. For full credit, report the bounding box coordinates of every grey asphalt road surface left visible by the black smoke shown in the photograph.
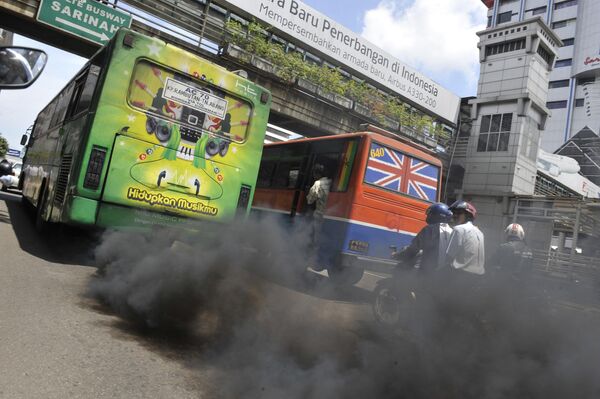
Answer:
[0,193,384,398]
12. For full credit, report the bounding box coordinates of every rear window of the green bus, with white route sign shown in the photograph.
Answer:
[128,60,251,142]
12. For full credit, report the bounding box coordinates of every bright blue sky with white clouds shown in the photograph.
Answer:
[0,0,487,149]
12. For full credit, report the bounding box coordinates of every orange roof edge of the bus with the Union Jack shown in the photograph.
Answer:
[265,131,442,166]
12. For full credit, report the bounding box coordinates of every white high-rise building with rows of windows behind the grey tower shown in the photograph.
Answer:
[482,0,600,152]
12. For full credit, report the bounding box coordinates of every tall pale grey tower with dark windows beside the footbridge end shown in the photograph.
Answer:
[462,18,561,196]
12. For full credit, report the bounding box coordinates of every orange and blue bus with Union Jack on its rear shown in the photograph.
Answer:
[252,131,442,284]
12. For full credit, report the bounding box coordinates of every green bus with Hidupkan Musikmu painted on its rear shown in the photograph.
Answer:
[19,29,271,229]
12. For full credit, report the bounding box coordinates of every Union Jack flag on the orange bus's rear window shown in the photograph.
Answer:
[365,143,439,201]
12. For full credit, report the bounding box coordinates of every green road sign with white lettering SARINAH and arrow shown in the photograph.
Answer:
[37,0,131,44]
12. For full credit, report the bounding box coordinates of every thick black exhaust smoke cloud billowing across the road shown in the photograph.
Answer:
[89,219,600,399]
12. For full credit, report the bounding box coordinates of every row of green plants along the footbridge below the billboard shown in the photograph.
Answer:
[225,20,447,143]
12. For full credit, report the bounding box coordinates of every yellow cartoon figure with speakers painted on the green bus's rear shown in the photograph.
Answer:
[129,61,251,199]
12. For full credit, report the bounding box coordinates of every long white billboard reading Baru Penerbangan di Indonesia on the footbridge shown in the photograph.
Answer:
[223,0,460,124]
